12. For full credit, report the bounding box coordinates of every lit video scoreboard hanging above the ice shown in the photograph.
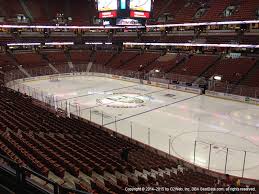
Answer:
[96,0,154,22]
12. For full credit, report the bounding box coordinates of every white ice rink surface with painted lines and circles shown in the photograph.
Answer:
[18,76,259,179]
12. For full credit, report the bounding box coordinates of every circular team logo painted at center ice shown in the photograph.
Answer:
[96,93,151,108]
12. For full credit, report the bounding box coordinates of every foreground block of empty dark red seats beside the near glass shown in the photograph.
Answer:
[0,88,258,194]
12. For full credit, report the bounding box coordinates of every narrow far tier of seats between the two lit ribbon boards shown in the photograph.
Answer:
[0,29,259,44]
